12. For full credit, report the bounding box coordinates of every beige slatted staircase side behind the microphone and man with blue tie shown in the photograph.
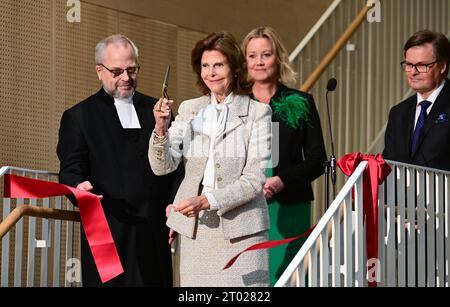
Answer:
[290,0,450,222]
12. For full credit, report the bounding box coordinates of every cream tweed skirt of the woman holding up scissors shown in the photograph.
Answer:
[179,211,270,287]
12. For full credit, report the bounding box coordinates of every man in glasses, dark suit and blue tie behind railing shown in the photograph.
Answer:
[383,30,450,171]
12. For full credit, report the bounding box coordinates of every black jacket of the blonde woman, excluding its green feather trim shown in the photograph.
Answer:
[255,85,327,204]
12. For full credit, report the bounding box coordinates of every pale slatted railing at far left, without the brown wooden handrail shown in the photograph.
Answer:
[0,166,81,287]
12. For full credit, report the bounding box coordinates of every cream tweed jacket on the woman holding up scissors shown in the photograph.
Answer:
[148,95,271,240]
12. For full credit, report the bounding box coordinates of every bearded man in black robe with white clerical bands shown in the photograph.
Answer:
[57,35,179,286]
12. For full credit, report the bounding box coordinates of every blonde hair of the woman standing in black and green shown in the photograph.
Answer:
[242,26,297,85]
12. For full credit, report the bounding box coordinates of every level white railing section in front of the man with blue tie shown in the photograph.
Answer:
[379,161,450,287]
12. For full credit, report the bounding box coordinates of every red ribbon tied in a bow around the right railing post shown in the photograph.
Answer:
[337,153,391,287]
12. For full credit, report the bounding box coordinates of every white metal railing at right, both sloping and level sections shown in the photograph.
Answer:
[275,161,450,287]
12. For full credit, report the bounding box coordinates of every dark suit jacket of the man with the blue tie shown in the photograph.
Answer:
[383,79,450,171]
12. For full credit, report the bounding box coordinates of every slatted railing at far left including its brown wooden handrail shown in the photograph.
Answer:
[0,166,81,287]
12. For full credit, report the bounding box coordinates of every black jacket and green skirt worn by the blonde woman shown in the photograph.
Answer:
[251,84,327,285]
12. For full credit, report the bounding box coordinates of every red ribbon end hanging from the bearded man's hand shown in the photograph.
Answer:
[4,174,123,283]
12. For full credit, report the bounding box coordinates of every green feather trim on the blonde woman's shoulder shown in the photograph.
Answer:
[272,92,311,129]
